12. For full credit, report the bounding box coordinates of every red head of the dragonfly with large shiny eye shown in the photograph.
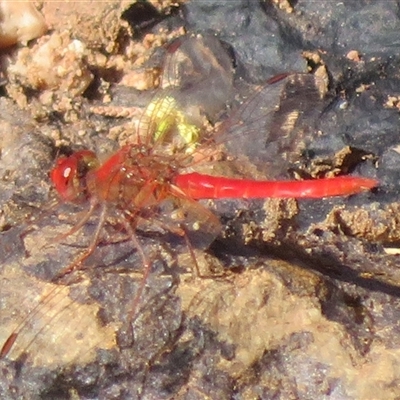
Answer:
[50,150,99,203]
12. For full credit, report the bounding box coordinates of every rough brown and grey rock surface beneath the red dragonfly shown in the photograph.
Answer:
[0,0,400,400]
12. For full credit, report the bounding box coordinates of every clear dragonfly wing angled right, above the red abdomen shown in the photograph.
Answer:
[216,74,324,178]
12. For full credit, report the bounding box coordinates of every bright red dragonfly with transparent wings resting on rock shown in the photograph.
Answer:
[0,36,378,357]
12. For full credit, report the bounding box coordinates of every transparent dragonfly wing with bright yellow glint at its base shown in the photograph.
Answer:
[138,35,234,148]
